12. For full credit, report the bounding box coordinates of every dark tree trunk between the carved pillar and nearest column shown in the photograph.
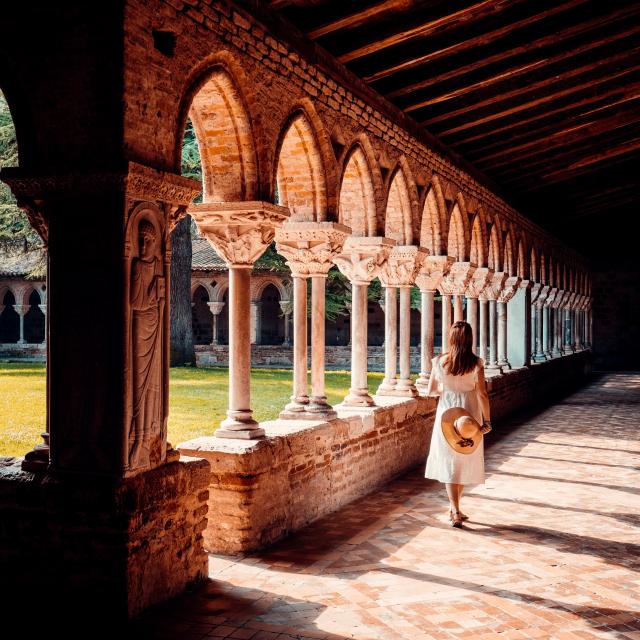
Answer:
[169,216,195,366]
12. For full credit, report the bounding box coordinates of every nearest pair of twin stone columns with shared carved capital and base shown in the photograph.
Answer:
[276,221,351,420]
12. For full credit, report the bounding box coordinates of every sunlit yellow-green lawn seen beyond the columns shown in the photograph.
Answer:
[0,363,382,456]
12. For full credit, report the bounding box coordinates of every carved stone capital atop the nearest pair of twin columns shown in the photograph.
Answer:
[275,221,351,278]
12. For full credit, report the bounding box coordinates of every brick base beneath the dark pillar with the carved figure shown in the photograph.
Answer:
[0,457,210,619]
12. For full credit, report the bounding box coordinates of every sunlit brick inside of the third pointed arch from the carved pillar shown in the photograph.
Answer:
[338,142,381,236]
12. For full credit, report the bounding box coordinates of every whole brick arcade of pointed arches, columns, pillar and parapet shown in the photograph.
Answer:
[0,0,608,616]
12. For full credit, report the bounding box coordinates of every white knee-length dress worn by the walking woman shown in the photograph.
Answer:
[424,356,484,486]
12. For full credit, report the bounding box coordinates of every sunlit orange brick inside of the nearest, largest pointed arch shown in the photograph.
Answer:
[177,59,260,202]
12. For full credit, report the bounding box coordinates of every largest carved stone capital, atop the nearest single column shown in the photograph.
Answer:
[188,201,289,268]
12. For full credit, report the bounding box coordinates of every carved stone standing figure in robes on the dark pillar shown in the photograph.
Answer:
[129,219,165,469]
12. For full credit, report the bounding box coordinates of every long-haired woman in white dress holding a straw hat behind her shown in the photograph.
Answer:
[425,321,491,528]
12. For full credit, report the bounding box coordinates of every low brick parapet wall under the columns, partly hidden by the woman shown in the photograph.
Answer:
[178,352,591,553]
